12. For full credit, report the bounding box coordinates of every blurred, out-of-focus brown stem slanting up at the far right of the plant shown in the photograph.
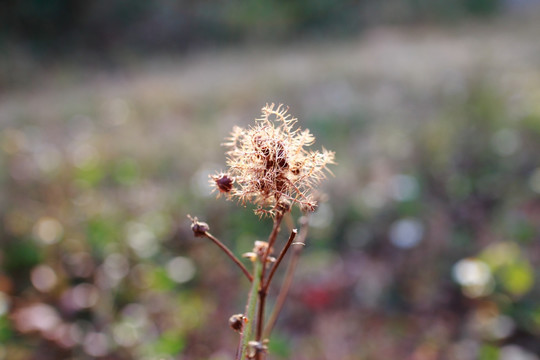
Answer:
[264,215,309,338]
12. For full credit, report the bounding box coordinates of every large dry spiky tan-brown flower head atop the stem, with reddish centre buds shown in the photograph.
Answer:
[211,104,334,216]
